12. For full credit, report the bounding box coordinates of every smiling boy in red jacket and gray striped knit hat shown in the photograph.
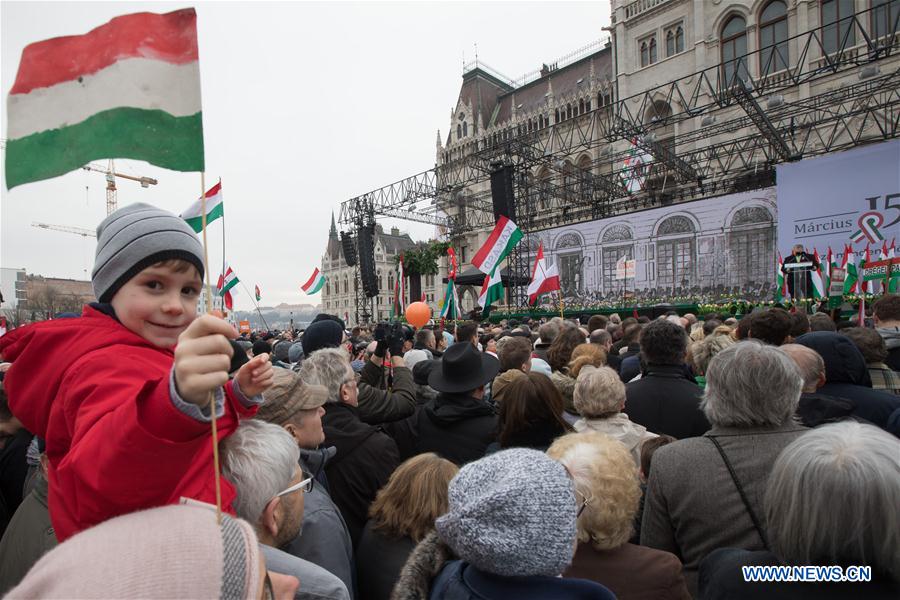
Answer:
[0,204,272,541]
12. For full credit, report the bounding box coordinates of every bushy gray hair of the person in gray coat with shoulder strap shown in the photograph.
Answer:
[701,340,803,427]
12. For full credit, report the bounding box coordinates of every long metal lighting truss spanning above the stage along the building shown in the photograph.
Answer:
[340,9,900,321]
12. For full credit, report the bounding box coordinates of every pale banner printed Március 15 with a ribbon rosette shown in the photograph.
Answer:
[777,140,900,264]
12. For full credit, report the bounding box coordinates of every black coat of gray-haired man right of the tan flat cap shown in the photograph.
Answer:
[322,402,400,548]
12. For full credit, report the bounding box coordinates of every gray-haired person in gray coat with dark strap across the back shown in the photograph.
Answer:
[641,340,808,595]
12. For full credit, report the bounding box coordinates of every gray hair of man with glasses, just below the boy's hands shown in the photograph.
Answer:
[222,419,300,527]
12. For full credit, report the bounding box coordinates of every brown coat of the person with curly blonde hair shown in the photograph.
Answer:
[563,542,691,600]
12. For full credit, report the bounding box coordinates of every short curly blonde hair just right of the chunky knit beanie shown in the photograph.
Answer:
[547,431,641,550]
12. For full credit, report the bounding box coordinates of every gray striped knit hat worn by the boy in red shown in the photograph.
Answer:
[91,202,203,302]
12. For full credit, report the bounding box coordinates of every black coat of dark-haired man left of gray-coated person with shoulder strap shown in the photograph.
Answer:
[622,365,710,440]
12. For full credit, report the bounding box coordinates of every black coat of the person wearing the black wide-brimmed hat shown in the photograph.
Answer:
[386,393,497,465]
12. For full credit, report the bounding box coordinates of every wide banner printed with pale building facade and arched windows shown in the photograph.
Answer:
[536,188,777,306]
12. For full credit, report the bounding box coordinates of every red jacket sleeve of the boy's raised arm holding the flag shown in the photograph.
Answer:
[47,351,248,535]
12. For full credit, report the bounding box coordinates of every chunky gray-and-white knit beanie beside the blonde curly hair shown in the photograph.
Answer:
[435,448,577,577]
